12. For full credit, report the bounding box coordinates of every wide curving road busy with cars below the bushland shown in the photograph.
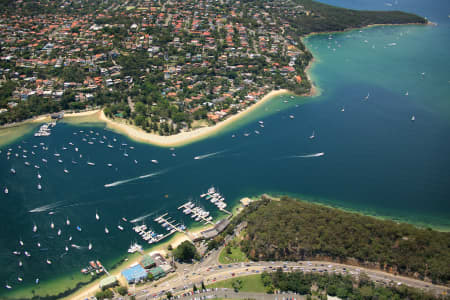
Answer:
[125,246,450,300]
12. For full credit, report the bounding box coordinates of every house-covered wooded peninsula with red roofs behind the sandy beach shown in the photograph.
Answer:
[0,0,427,136]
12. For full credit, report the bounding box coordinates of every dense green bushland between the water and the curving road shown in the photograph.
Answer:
[230,197,450,284]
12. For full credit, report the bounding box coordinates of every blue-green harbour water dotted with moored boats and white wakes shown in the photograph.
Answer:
[0,1,450,298]
